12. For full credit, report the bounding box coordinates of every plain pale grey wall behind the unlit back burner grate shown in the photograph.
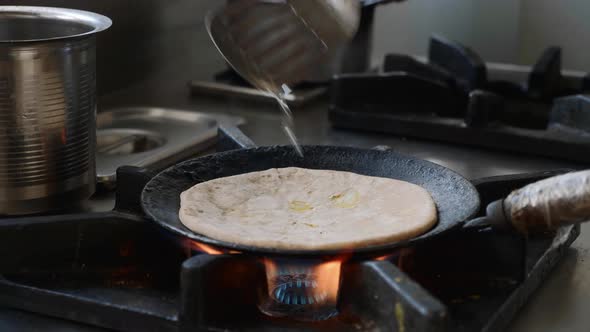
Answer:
[374,0,590,71]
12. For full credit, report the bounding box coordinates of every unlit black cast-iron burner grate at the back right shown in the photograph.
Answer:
[330,37,590,162]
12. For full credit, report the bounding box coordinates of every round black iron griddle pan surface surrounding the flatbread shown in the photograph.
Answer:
[141,146,479,257]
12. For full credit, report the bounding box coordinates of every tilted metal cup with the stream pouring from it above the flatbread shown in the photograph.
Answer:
[205,0,361,156]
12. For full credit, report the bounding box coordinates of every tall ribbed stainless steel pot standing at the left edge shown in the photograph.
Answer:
[0,6,111,215]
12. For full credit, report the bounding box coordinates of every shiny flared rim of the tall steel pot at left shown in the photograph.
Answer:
[0,6,113,44]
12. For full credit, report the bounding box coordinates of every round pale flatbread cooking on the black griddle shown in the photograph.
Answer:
[179,167,437,250]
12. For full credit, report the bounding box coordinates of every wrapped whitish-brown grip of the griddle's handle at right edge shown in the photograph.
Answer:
[504,170,590,233]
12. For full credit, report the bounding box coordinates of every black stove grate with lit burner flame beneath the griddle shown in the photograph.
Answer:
[0,127,580,331]
